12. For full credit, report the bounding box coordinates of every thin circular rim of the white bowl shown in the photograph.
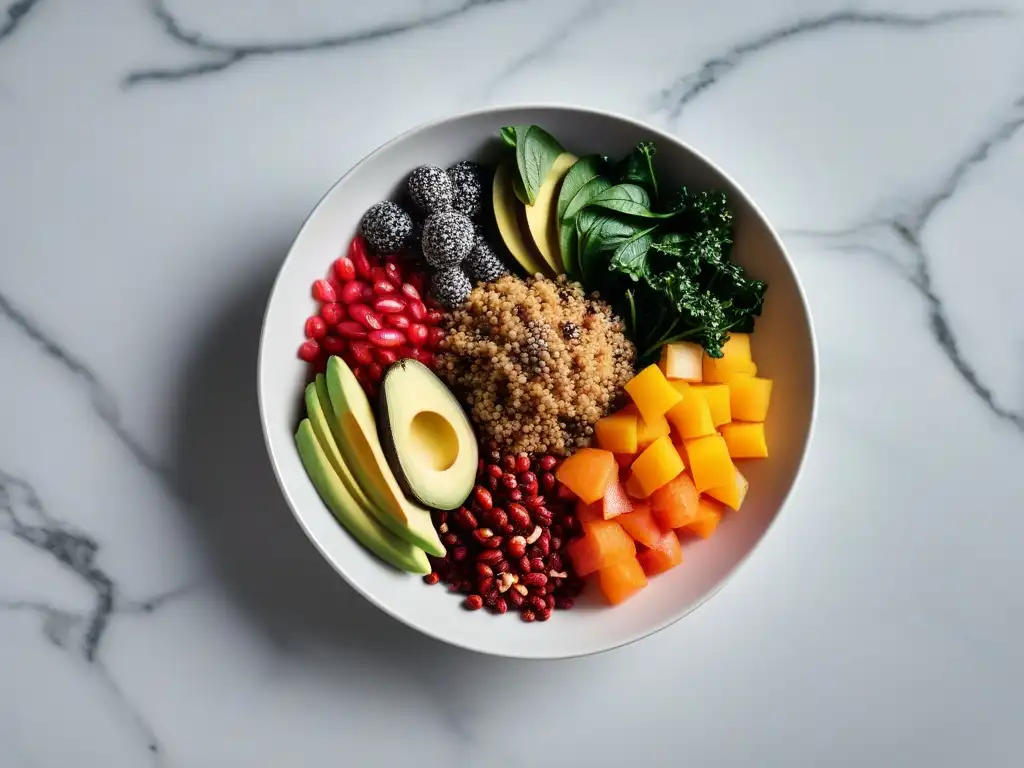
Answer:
[256,101,820,660]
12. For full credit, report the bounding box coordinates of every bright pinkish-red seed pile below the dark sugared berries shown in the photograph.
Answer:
[299,234,444,396]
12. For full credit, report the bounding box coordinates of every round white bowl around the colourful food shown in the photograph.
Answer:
[258,106,817,658]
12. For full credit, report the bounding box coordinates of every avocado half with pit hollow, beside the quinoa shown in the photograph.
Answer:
[380,359,478,509]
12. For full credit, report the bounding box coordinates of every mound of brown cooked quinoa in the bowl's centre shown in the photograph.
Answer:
[438,275,636,456]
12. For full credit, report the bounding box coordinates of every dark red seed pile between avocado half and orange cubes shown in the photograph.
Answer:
[424,442,584,622]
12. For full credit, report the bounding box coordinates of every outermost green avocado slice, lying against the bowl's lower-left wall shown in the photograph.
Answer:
[295,419,430,573]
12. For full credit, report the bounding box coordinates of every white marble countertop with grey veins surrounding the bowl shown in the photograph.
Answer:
[0,0,1024,768]
